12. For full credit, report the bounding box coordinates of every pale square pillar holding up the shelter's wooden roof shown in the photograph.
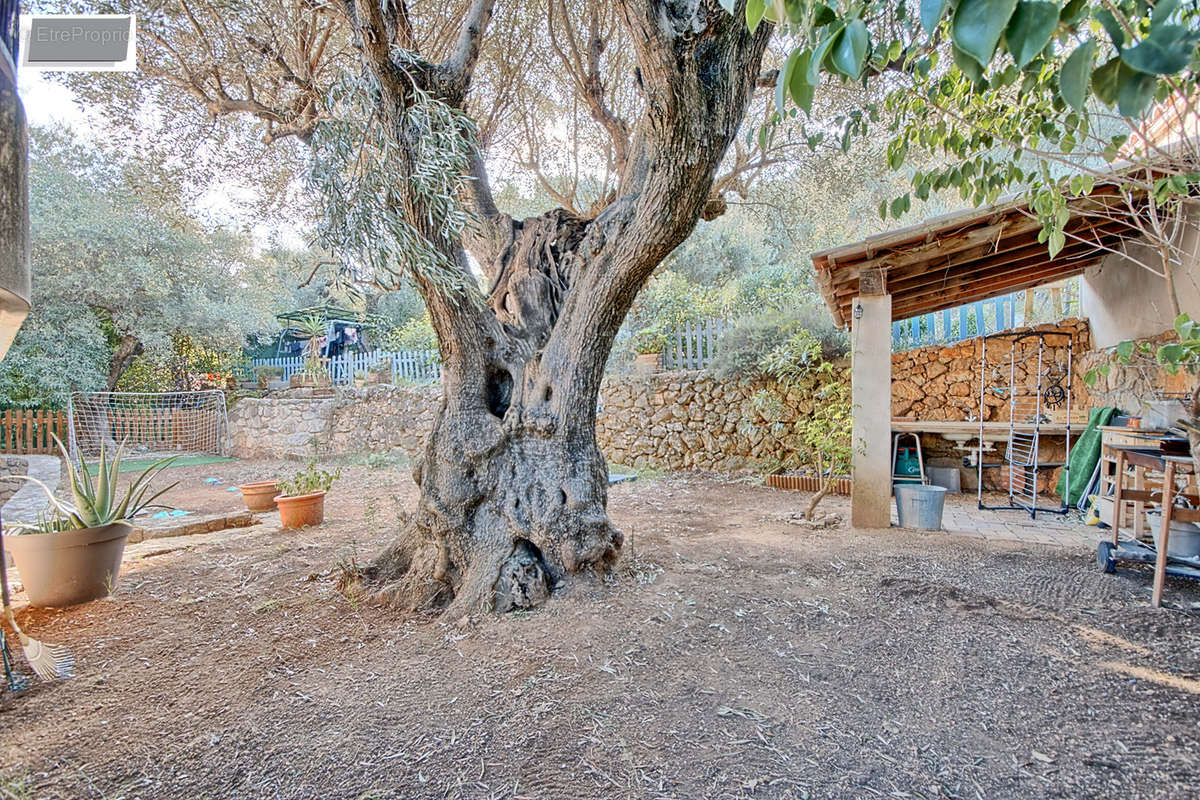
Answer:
[850,294,892,528]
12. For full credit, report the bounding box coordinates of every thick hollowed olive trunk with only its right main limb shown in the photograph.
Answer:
[365,0,769,615]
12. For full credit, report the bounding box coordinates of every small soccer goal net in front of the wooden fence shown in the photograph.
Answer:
[67,390,229,458]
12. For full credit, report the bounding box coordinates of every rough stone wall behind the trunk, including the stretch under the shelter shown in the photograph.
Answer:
[230,320,1113,471]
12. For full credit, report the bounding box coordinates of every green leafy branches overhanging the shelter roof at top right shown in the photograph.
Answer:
[727,0,1200,314]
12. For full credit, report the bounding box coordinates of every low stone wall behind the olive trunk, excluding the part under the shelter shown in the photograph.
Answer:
[229,372,844,470]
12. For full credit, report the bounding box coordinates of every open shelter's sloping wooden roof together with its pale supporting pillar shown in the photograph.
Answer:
[812,181,1141,528]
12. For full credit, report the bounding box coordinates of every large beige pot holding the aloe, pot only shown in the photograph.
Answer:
[4,523,131,608]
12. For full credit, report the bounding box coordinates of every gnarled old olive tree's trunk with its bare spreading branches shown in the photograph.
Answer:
[131,0,770,613]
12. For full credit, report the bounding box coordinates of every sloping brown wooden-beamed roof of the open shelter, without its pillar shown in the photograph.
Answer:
[812,193,1138,327]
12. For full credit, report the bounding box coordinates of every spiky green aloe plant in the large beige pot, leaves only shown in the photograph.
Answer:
[25,437,179,528]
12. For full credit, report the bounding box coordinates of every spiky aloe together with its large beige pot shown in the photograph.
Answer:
[7,437,178,607]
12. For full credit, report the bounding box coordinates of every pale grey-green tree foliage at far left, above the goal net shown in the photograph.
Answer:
[2,128,275,405]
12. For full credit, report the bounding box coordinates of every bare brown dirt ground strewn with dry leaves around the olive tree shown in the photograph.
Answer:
[0,455,1200,800]
